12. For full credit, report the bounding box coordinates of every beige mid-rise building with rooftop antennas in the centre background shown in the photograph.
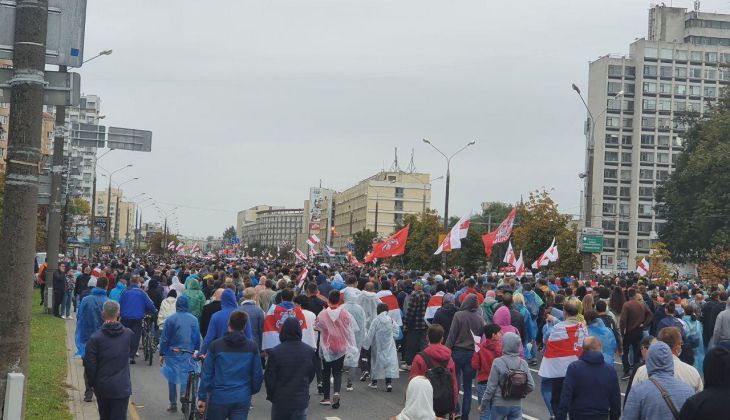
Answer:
[333,171,431,252]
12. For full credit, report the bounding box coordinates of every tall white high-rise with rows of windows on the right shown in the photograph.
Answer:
[582,6,730,271]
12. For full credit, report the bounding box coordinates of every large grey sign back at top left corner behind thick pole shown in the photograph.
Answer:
[0,0,86,67]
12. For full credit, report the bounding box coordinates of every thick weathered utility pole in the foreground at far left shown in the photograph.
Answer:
[0,0,48,408]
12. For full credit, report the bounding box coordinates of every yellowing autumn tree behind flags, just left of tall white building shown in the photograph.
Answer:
[512,190,581,276]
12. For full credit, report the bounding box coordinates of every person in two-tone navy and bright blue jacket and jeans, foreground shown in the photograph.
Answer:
[198,310,264,420]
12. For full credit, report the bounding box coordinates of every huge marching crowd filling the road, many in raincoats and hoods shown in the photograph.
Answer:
[44,256,730,420]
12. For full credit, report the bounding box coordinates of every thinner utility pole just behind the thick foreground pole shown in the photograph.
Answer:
[46,66,70,313]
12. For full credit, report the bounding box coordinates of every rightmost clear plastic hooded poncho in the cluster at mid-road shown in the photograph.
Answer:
[363,311,400,380]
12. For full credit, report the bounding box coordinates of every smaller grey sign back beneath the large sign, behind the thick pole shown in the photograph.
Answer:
[0,67,81,106]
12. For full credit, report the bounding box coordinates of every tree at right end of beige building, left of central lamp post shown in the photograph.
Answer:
[394,210,441,270]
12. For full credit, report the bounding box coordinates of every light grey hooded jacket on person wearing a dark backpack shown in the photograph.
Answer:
[481,332,535,409]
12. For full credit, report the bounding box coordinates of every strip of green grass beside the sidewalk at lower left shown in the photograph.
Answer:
[25,290,72,420]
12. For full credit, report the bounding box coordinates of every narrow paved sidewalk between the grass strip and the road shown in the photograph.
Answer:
[66,314,99,420]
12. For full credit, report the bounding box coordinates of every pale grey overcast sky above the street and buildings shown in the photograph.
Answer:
[80,0,730,236]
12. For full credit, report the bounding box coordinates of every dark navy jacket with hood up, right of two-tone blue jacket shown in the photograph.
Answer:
[264,317,318,412]
